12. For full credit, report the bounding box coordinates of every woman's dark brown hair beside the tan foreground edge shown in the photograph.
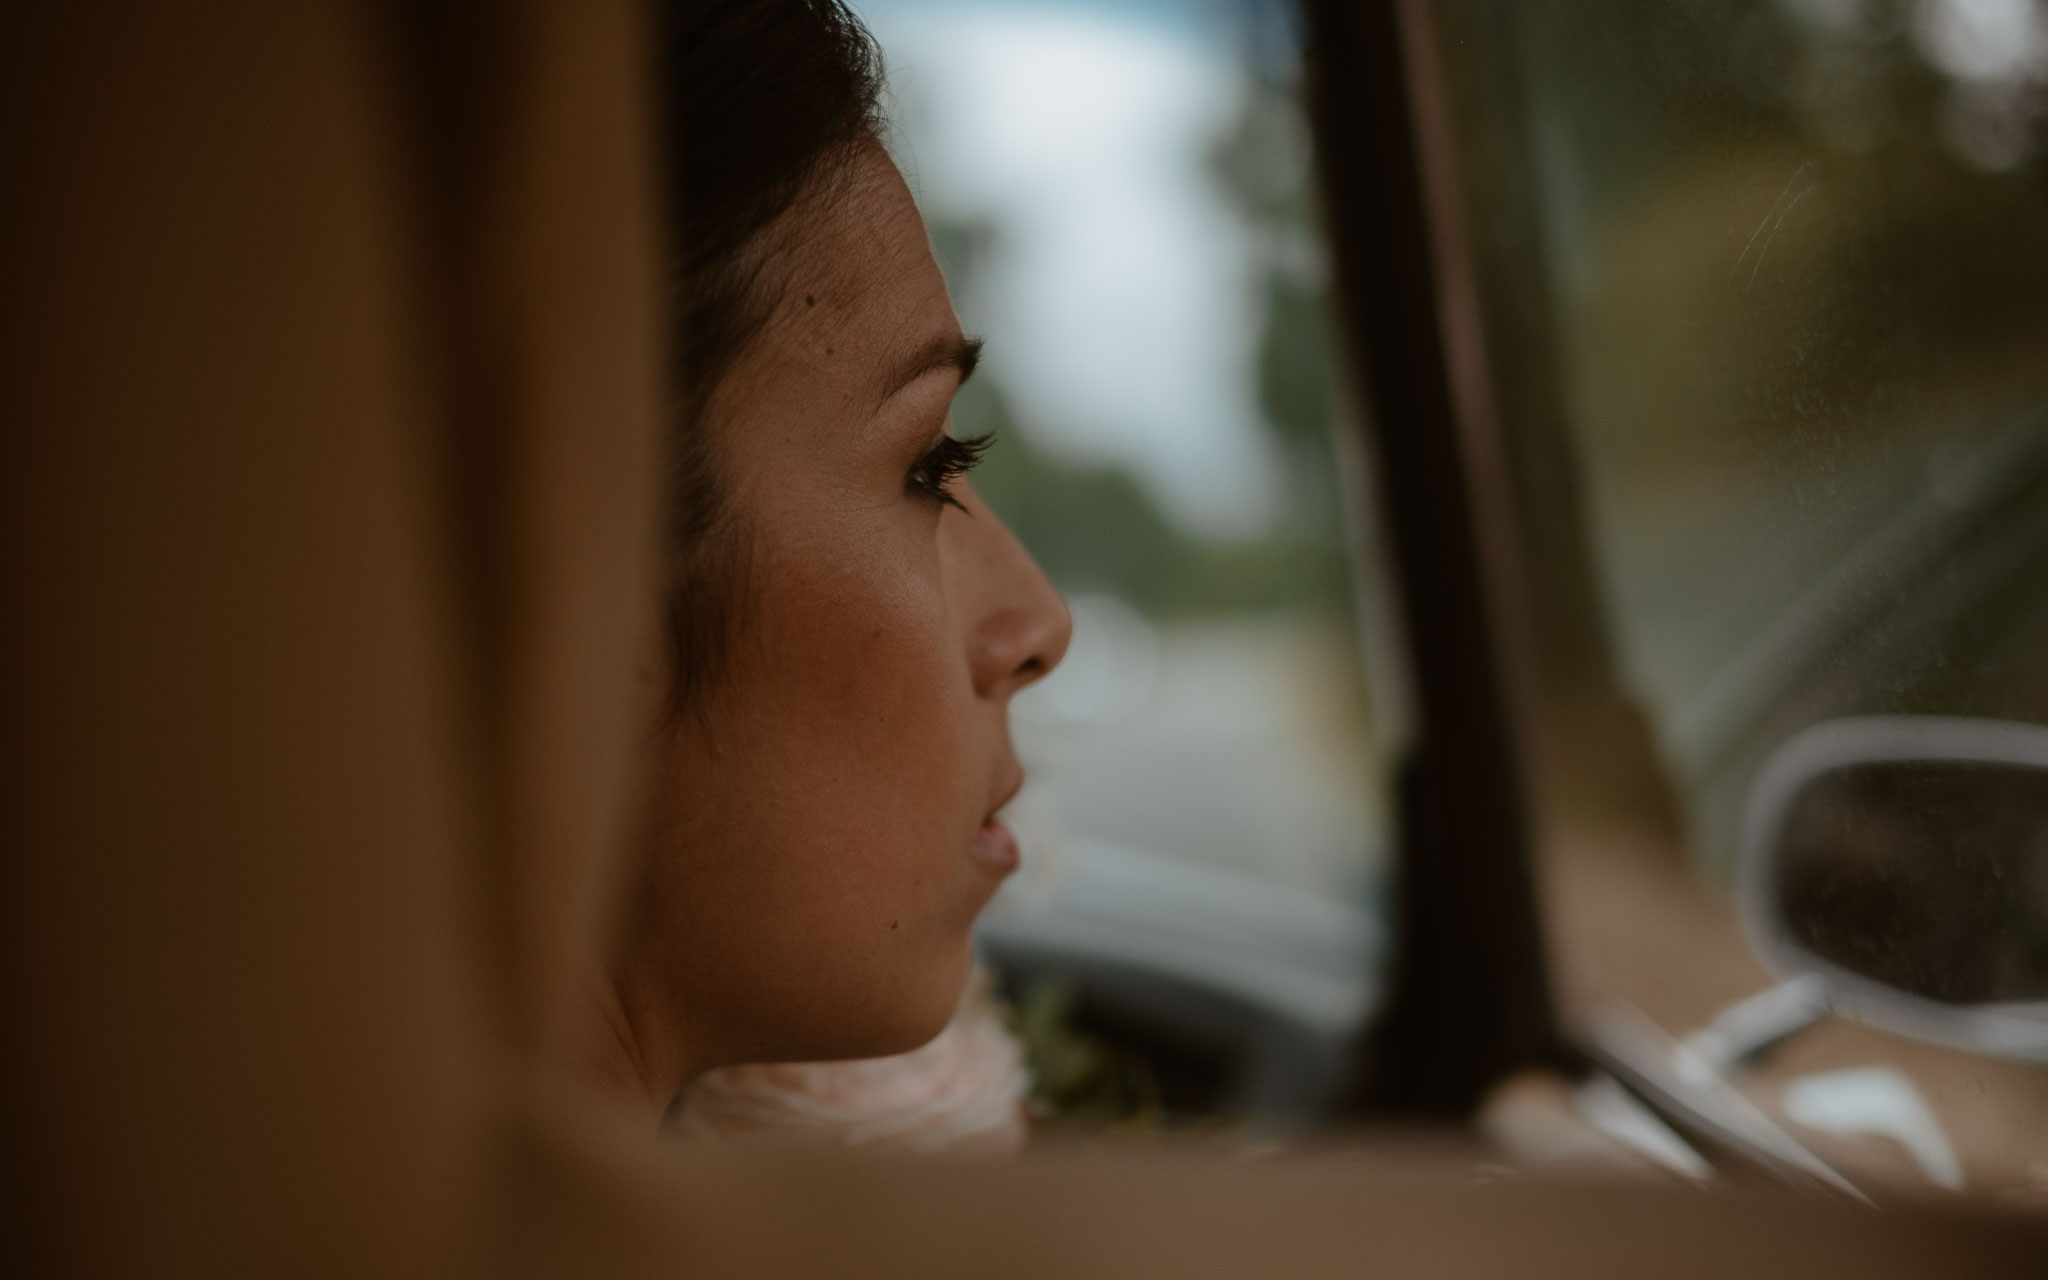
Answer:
[657,0,883,711]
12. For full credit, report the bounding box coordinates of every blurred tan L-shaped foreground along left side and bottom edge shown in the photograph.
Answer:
[0,0,2042,1278]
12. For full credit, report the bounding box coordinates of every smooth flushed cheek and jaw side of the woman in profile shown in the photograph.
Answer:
[657,520,995,1053]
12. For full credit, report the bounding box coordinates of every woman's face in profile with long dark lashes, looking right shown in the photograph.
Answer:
[621,145,1069,1069]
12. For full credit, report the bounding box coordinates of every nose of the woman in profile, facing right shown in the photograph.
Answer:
[946,483,1073,700]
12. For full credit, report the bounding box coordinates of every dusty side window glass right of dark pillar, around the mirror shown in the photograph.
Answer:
[1432,0,2048,1182]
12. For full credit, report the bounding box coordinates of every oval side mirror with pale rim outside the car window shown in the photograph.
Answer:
[1739,717,2048,1061]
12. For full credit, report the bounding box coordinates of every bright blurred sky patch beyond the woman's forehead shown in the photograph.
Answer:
[856,0,1280,537]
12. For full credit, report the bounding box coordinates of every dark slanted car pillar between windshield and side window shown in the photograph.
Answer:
[1305,0,1581,1118]
